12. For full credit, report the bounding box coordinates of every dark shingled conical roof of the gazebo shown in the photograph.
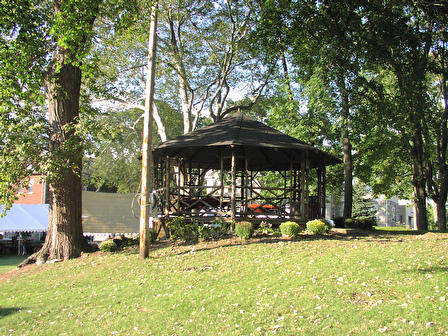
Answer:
[154,113,341,170]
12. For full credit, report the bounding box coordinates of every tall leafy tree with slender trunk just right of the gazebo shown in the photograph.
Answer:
[260,0,368,217]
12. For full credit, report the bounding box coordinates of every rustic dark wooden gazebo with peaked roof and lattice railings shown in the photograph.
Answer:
[153,113,341,223]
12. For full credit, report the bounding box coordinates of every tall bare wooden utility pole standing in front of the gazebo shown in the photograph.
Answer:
[140,1,157,259]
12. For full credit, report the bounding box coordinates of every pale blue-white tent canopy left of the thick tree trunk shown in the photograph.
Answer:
[0,204,48,232]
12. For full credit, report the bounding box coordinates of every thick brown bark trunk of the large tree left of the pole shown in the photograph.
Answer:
[19,51,88,265]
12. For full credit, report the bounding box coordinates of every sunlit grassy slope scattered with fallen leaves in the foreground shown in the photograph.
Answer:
[0,232,448,335]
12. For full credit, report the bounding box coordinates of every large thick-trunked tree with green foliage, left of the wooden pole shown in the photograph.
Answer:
[0,0,140,262]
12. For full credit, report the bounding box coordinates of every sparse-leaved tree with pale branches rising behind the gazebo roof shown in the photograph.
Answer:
[91,0,269,141]
